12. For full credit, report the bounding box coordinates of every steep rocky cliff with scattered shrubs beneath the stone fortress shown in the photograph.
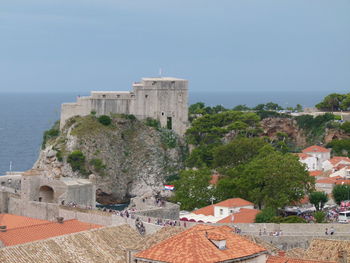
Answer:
[34,115,185,204]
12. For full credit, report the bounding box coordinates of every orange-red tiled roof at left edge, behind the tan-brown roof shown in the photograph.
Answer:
[0,215,101,246]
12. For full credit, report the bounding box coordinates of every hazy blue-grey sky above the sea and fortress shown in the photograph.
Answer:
[0,0,350,93]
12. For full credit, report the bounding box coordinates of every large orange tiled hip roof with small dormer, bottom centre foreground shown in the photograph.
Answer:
[135,225,267,263]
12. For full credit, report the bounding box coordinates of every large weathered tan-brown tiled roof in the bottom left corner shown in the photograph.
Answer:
[0,225,143,263]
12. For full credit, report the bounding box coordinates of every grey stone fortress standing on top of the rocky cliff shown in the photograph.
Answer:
[60,77,188,136]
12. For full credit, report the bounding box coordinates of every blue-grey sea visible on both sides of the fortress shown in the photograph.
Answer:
[0,92,327,175]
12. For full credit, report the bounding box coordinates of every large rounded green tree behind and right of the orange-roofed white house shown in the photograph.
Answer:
[233,146,314,208]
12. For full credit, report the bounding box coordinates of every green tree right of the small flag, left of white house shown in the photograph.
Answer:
[172,169,214,210]
